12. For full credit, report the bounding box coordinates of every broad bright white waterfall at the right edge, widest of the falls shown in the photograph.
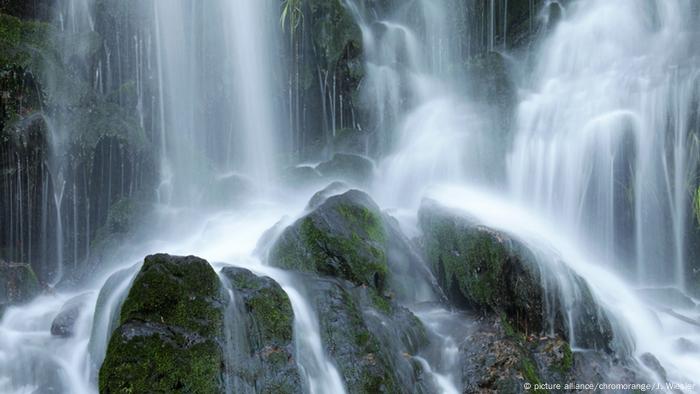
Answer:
[508,1,700,289]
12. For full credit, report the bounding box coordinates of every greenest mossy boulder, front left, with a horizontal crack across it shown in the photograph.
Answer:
[99,254,224,393]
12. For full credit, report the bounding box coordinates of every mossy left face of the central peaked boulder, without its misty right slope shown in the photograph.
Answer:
[269,190,389,292]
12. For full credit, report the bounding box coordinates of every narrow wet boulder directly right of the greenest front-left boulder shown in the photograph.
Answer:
[222,267,302,393]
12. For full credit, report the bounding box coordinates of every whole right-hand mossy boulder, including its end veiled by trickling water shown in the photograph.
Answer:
[419,200,614,351]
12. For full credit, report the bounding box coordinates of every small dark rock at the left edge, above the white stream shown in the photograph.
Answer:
[0,260,41,306]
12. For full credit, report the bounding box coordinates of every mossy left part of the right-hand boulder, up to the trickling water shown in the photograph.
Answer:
[419,201,544,332]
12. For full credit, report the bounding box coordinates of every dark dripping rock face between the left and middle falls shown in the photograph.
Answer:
[285,0,364,158]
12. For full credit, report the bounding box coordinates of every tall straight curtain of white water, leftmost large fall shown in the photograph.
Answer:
[153,0,278,204]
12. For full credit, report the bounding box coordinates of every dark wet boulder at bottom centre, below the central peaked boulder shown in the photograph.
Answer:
[304,277,428,393]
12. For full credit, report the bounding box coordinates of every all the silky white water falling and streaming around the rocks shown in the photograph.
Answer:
[0,0,700,393]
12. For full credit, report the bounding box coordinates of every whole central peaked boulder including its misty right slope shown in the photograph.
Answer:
[268,189,439,302]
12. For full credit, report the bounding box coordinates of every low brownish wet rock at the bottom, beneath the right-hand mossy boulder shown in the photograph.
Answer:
[459,316,645,393]
